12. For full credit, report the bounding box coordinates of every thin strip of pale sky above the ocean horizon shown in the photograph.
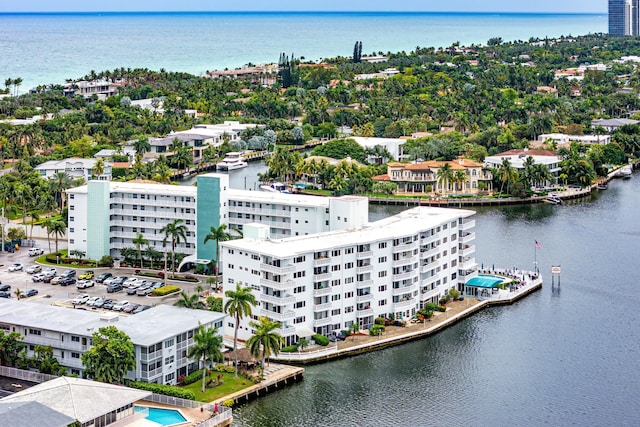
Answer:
[0,0,607,13]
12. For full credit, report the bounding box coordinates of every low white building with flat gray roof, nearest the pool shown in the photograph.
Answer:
[0,300,226,385]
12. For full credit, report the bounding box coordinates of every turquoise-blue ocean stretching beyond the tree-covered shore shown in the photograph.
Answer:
[0,12,607,92]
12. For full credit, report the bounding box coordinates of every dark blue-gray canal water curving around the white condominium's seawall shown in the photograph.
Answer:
[232,171,640,427]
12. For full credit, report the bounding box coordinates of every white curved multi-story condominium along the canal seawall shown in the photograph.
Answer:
[221,207,477,345]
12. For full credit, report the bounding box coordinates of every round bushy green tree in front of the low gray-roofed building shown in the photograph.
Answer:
[81,326,136,384]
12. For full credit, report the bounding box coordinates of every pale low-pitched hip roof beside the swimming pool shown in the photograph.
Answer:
[0,377,152,426]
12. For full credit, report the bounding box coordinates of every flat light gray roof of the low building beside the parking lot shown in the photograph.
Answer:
[0,298,226,346]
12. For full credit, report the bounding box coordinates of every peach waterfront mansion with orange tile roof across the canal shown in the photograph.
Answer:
[373,158,493,195]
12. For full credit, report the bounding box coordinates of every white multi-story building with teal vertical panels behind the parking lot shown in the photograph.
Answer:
[67,174,368,268]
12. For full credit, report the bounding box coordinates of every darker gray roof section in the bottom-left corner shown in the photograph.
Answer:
[0,401,75,427]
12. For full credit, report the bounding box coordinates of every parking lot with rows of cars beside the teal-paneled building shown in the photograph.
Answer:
[0,248,215,311]
